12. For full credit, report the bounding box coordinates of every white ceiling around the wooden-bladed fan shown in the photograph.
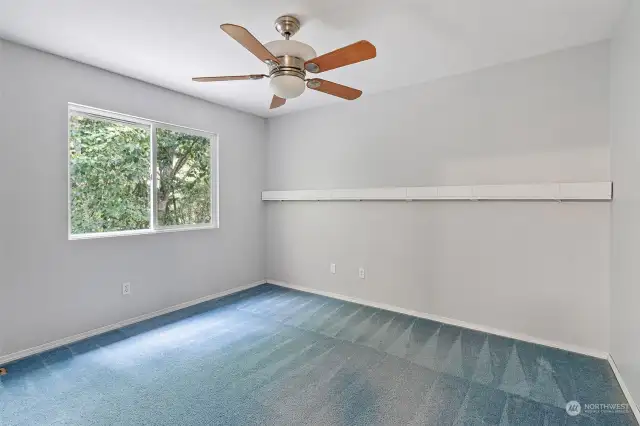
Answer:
[0,0,627,117]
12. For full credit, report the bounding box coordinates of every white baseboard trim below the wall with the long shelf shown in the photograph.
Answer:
[267,279,609,359]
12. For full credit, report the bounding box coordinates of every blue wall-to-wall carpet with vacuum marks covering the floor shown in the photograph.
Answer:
[0,285,637,426]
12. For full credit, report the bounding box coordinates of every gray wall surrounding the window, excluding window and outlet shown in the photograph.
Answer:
[0,42,266,356]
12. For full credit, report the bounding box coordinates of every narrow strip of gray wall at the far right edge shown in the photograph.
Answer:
[611,0,640,402]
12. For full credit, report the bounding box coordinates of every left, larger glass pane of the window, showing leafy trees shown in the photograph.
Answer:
[69,114,151,234]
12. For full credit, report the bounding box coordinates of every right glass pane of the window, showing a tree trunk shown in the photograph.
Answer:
[156,128,211,226]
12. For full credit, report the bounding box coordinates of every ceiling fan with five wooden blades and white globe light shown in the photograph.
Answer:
[193,15,376,109]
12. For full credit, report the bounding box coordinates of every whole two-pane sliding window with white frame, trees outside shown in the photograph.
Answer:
[69,104,218,239]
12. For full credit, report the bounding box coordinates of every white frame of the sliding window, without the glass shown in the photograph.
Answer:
[67,102,220,240]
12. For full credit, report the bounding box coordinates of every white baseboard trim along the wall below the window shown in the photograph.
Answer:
[0,280,266,366]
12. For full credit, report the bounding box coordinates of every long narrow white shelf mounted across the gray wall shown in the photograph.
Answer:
[262,182,613,201]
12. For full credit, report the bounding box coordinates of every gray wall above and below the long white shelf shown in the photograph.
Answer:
[267,42,610,351]
